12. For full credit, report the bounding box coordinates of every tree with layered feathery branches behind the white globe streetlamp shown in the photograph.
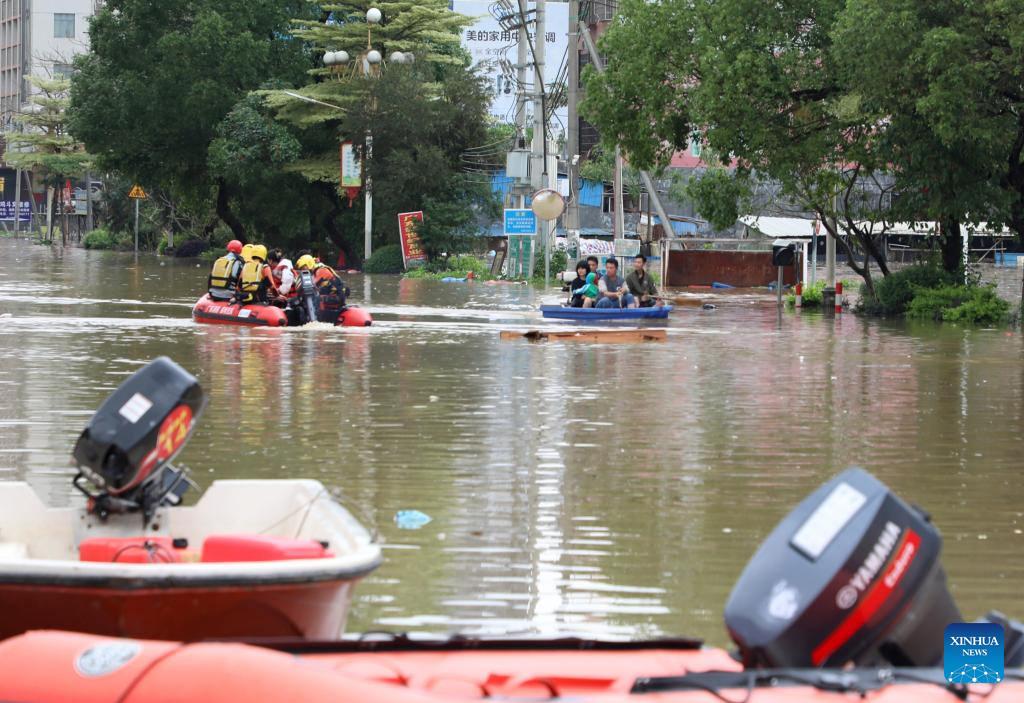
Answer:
[265,0,494,255]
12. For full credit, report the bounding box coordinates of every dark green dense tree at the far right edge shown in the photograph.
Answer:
[836,0,1024,292]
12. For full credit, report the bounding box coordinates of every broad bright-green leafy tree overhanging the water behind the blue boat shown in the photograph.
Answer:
[585,0,1014,293]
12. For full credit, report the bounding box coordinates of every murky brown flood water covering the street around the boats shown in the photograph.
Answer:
[0,239,1024,645]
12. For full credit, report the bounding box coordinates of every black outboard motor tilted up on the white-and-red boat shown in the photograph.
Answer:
[74,356,206,523]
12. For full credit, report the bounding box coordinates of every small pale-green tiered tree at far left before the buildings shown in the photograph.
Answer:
[4,76,91,243]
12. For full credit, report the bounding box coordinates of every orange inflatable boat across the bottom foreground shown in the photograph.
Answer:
[0,631,1024,703]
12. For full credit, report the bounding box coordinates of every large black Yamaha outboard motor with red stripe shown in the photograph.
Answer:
[725,469,962,667]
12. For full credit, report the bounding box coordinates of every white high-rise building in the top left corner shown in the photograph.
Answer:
[0,0,99,123]
